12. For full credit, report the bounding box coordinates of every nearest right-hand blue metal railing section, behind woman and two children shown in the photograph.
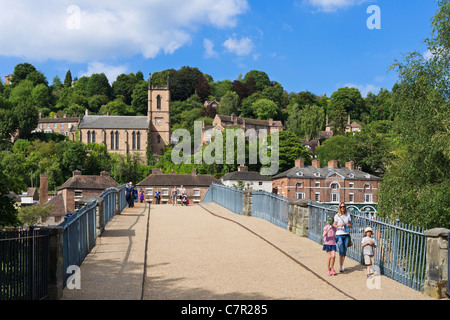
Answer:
[308,202,427,291]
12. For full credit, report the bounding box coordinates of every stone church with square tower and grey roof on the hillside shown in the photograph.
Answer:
[71,76,171,160]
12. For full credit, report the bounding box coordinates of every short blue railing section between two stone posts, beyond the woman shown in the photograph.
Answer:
[252,191,289,229]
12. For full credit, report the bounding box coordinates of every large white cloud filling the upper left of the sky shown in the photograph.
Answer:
[0,0,249,62]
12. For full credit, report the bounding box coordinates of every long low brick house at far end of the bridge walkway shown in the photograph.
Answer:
[136,169,221,204]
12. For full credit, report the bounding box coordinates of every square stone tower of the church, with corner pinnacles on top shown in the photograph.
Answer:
[147,74,171,156]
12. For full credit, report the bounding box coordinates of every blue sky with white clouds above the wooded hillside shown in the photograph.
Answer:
[0,0,437,96]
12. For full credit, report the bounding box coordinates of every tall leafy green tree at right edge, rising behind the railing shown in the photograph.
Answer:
[379,0,450,228]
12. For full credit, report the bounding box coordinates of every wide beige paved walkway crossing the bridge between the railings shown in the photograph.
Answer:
[63,203,427,300]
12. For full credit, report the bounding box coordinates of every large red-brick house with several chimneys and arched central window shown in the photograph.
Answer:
[272,159,380,204]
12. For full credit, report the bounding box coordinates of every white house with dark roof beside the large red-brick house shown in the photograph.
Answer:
[221,166,272,193]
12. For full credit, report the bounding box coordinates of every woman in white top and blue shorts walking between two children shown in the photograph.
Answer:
[334,202,352,272]
